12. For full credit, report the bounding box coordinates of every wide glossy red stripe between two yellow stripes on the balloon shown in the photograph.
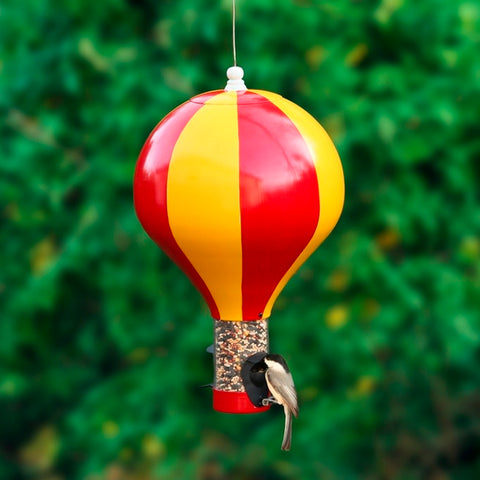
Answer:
[238,92,320,320]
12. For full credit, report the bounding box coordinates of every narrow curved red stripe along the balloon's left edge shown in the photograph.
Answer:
[133,98,219,318]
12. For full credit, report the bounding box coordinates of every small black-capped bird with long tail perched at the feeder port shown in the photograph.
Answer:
[262,353,298,450]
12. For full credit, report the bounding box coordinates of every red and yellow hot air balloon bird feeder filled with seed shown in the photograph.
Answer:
[134,0,344,413]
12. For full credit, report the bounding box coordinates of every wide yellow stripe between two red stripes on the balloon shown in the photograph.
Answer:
[167,92,242,320]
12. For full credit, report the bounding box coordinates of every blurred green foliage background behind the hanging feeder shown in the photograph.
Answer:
[0,0,480,480]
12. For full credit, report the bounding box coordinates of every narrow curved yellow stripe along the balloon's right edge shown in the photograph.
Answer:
[251,90,345,317]
